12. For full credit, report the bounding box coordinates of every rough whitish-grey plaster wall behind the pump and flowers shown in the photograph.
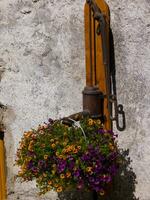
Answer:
[0,0,150,200]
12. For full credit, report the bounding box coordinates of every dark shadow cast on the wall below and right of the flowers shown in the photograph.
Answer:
[59,150,139,200]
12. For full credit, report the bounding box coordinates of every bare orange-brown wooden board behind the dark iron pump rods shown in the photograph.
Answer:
[84,0,112,130]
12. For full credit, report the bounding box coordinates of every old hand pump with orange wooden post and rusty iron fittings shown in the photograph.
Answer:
[83,0,125,200]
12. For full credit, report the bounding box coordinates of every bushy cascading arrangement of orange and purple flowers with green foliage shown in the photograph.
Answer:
[16,117,120,195]
